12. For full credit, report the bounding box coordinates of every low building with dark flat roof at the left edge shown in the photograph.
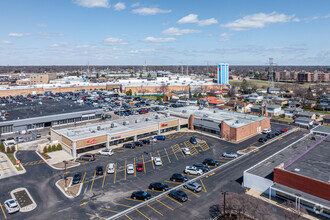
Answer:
[0,99,103,134]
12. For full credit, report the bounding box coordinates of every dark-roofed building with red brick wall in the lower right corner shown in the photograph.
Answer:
[243,126,330,218]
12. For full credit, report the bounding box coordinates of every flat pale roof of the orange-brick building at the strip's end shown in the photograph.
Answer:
[163,106,267,128]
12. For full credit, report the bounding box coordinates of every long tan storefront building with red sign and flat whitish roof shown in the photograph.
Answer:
[51,114,188,158]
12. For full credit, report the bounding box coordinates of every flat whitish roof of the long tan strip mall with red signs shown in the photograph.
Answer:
[55,113,181,141]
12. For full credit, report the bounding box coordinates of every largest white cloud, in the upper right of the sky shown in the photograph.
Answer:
[221,12,295,31]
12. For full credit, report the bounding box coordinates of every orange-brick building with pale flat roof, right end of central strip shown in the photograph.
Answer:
[163,106,270,142]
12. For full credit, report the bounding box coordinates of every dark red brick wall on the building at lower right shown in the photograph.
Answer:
[274,168,330,200]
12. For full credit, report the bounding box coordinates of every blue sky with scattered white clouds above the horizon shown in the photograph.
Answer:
[0,0,330,65]
